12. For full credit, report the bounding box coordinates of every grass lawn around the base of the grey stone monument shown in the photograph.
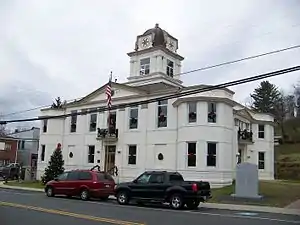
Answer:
[210,180,300,207]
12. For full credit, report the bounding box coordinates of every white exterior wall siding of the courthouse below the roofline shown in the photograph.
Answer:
[38,85,274,186]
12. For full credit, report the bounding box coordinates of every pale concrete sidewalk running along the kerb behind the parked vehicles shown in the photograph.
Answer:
[0,182,300,216]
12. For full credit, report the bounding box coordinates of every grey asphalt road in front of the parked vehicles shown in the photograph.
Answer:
[0,189,300,225]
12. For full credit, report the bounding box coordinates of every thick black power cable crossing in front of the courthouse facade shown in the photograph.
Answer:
[0,66,300,124]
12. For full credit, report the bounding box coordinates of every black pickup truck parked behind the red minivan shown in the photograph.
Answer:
[115,171,211,209]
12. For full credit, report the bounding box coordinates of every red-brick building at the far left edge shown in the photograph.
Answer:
[0,136,17,166]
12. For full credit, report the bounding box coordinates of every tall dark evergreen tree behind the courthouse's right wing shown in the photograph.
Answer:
[250,81,281,114]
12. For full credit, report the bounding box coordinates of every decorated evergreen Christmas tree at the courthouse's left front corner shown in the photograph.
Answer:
[42,144,65,184]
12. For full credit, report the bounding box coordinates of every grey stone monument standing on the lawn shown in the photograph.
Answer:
[231,162,262,199]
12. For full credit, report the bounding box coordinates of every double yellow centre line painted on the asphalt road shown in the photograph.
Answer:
[0,201,145,225]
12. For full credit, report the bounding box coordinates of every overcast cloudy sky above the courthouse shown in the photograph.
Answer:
[0,0,300,128]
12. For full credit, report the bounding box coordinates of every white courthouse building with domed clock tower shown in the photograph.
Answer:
[38,25,274,187]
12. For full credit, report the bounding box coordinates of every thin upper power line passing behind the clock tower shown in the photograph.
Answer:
[2,45,300,117]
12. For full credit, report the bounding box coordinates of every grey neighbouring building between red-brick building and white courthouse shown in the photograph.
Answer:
[9,127,40,178]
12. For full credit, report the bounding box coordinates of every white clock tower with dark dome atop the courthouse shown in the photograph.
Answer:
[127,24,184,86]
